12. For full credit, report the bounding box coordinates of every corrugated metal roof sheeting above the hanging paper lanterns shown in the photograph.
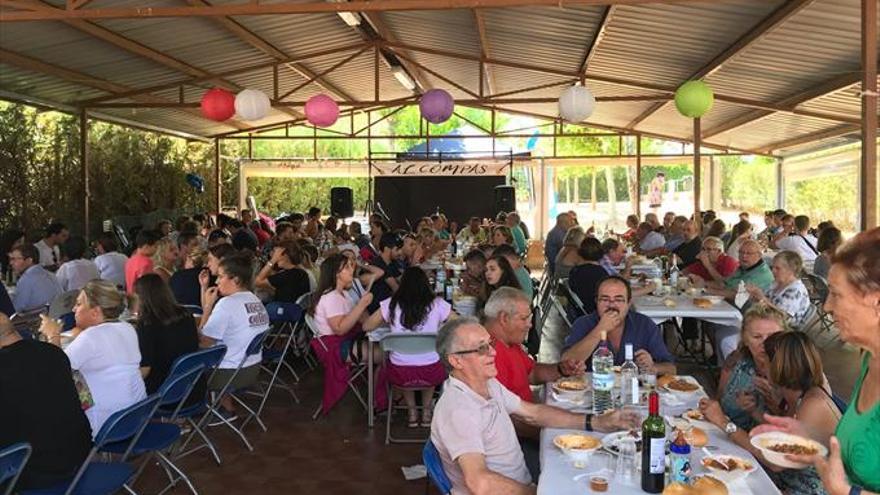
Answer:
[0,0,860,149]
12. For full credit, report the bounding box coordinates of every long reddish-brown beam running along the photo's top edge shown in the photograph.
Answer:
[0,0,705,22]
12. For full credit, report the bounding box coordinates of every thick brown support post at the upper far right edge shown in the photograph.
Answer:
[860,0,880,230]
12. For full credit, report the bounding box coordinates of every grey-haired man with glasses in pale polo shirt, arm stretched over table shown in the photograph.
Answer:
[431,317,641,494]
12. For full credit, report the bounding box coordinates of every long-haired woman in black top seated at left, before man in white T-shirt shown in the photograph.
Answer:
[134,273,199,394]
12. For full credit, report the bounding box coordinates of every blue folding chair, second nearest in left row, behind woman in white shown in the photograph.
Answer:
[101,366,205,495]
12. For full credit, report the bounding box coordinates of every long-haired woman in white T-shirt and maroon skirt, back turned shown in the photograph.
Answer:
[364,267,452,428]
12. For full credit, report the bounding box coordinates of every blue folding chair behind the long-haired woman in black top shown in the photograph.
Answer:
[165,344,226,466]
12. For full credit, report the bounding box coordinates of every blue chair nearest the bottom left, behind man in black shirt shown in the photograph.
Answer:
[21,394,159,495]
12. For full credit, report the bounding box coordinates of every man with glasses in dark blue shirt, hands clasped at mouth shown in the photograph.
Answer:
[562,276,675,375]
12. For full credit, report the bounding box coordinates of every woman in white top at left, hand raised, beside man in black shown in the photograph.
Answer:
[40,280,147,436]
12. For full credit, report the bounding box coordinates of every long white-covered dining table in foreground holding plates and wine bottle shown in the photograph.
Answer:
[538,374,780,495]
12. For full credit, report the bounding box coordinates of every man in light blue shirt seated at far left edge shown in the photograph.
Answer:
[9,244,62,313]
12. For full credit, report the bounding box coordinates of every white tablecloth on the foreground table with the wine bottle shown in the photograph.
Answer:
[538,387,780,495]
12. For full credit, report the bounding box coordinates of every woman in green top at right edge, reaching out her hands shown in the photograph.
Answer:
[752,228,880,495]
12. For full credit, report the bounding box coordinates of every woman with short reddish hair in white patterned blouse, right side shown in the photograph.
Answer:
[747,251,811,328]
